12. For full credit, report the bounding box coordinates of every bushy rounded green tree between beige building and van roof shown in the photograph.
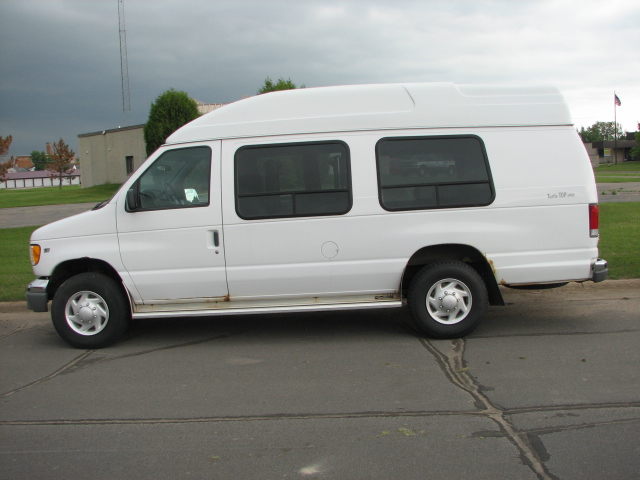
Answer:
[144,88,200,155]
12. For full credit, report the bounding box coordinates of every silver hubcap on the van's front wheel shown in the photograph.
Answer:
[65,291,109,336]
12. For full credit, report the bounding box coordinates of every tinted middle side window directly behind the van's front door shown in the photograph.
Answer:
[235,142,351,220]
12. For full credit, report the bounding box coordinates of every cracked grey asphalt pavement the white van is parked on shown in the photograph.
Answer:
[0,280,640,479]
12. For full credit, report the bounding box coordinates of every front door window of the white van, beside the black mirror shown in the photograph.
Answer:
[129,147,211,210]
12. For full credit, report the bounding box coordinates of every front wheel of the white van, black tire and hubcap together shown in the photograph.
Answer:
[51,273,131,349]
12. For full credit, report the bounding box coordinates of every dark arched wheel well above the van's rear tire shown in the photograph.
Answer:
[402,243,504,305]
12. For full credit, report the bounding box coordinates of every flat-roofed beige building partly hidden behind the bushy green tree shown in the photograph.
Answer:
[78,100,226,188]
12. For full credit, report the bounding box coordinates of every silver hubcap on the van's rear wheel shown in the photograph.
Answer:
[426,278,471,325]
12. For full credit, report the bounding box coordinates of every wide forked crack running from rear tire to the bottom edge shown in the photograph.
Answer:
[420,337,558,480]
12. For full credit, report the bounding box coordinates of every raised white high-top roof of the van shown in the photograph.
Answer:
[166,83,572,144]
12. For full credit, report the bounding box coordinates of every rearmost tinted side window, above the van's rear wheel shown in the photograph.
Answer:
[376,136,495,210]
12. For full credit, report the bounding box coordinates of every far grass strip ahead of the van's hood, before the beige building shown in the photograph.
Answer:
[0,183,120,208]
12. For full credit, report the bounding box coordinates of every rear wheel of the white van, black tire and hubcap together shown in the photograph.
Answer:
[409,260,489,338]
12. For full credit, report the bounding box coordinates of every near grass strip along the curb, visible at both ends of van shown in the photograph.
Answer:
[0,203,640,302]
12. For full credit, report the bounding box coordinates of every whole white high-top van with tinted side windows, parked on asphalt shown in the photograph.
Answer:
[27,83,607,348]
